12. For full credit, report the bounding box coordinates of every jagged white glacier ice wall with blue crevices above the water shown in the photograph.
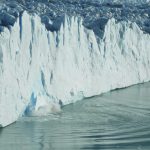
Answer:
[0,12,150,126]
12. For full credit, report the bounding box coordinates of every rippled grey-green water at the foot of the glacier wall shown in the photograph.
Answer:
[0,83,150,150]
